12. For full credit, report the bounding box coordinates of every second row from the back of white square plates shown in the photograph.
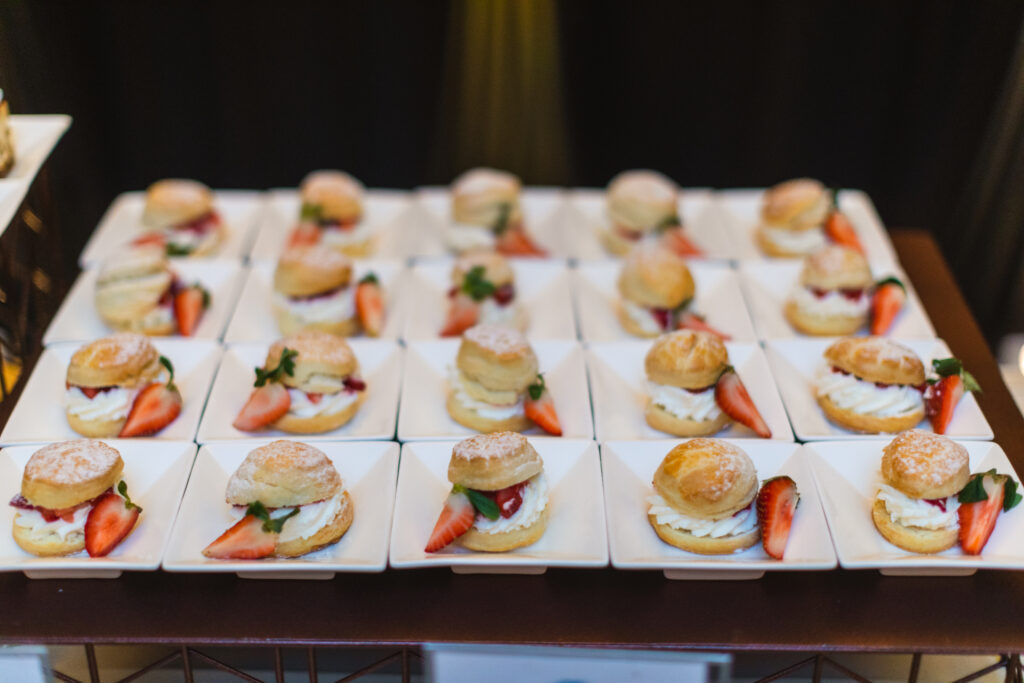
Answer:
[44,258,935,344]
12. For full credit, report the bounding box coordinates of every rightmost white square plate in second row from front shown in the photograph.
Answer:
[765,338,993,441]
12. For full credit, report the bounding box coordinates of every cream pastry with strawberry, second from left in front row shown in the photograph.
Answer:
[203,440,354,560]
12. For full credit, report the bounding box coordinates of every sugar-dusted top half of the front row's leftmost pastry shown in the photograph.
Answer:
[22,438,124,510]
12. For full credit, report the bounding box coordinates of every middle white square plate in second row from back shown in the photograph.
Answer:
[402,258,575,339]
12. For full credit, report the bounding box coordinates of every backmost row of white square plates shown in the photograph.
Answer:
[80,187,897,266]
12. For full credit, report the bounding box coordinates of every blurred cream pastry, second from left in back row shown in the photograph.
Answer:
[289,171,373,257]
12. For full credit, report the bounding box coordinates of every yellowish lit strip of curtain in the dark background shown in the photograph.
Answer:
[432,0,568,184]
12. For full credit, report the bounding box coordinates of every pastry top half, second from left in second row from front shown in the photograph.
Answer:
[263,330,359,393]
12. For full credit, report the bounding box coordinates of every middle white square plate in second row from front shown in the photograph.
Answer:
[398,339,594,441]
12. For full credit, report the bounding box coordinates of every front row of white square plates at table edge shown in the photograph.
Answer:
[0,437,1024,580]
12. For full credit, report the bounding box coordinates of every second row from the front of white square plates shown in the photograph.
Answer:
[0,339,993,444]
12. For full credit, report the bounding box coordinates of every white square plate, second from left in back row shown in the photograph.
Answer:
[251,189,413,261]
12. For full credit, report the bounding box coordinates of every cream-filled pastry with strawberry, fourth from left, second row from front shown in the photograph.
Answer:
[644,330,771,438]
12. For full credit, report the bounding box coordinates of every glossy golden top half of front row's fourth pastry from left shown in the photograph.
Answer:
[653,438,758,519]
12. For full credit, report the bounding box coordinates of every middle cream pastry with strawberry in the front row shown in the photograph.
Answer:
[425,431,548,553]
